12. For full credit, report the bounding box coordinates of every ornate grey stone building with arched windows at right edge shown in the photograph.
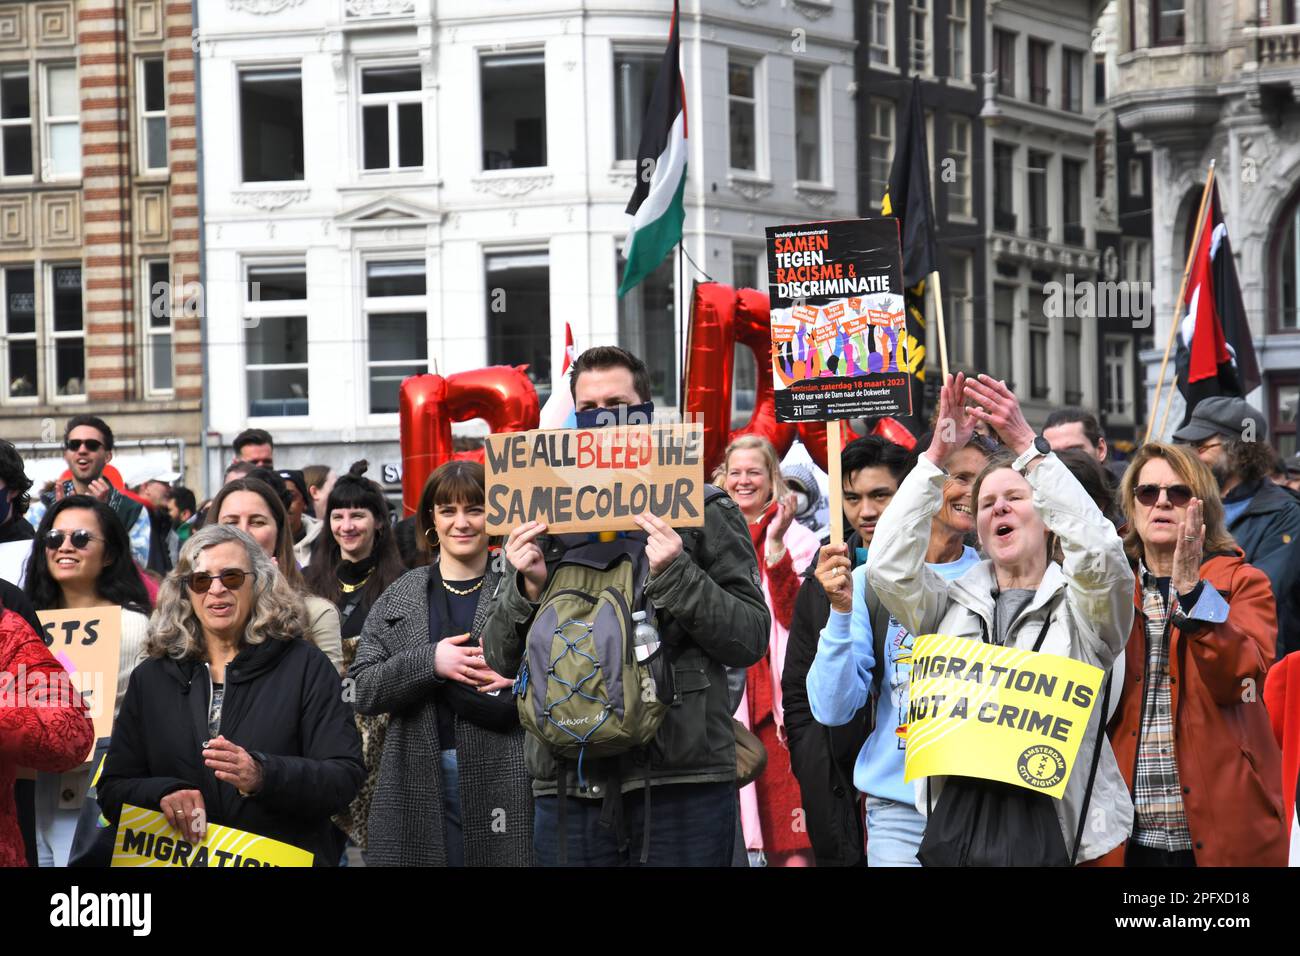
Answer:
[1113,0,1300,455]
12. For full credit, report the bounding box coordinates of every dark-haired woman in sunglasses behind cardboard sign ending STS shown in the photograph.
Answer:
[23,494,150,866]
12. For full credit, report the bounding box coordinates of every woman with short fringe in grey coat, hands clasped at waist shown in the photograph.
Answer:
[351,462,533,866]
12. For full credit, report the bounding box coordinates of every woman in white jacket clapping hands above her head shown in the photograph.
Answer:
[867,375,1134,865]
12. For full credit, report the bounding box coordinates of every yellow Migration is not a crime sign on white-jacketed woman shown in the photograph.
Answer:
[904,633,1105,799]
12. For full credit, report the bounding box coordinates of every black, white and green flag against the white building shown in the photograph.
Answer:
[619,0,686,297]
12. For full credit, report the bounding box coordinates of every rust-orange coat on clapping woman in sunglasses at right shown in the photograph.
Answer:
[1110,550,1287,866]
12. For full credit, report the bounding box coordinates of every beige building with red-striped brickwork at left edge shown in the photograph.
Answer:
[0,0,202,479]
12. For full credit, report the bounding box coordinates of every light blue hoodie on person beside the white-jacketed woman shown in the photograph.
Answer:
[807,548,979,806]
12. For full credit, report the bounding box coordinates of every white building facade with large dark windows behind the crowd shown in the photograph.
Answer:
[198,0,857,477]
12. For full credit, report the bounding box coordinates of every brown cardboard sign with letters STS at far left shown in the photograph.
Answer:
[36,605,122,740]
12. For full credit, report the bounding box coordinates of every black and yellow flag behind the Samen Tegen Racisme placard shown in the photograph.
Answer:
[880,77,939,432]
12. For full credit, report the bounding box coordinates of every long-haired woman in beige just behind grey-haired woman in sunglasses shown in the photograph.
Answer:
[208,475,343,674]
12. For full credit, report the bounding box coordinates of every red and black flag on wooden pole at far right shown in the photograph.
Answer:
[1174,182,1260,427]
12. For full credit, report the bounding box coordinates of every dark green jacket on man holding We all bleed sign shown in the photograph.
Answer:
[482,496,771,799]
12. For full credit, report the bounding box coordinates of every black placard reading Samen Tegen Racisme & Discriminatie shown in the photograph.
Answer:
[767,219,909,421]
